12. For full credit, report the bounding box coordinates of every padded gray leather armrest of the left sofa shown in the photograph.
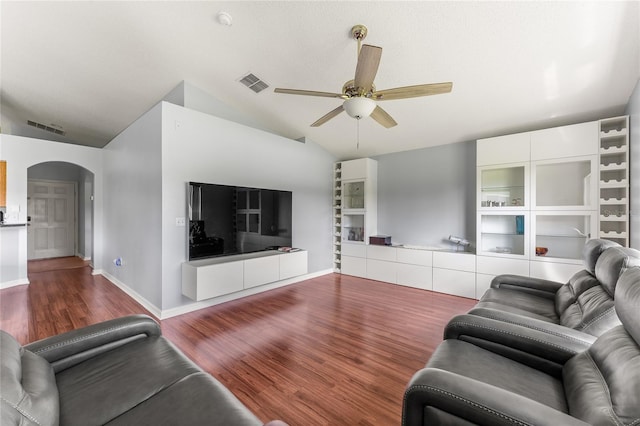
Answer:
[24,315,162,373]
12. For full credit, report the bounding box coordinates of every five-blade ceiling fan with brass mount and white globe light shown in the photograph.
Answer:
[274,25,453,128]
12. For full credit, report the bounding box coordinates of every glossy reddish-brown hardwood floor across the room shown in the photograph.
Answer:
[0,256,475,426]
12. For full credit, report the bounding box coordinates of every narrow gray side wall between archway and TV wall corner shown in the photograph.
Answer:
[103,104,162,308]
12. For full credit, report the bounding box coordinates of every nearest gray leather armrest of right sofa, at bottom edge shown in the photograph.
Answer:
[402,368,587,426]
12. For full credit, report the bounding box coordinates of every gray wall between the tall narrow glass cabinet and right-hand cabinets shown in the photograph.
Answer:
[375,141,476,249]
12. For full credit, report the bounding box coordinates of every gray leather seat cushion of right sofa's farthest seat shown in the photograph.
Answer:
[469,288,560,324]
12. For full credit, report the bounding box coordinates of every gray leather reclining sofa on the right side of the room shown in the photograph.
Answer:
[402,240,640,426]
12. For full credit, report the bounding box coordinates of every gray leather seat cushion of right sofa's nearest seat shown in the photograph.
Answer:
[427,339,568,413]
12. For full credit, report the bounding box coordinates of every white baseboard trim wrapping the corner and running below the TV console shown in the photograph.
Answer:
[99,269,333,320]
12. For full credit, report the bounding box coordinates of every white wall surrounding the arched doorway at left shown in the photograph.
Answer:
[0,134,103,284]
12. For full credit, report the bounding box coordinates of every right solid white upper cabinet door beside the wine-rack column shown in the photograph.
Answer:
[531,121,599,161]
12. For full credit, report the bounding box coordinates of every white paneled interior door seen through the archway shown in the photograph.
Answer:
[27,180,76,259]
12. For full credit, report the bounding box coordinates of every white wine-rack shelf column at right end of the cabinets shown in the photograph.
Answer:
[598,116,629,247]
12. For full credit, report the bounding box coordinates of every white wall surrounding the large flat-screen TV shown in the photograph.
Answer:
[162,102,335,309]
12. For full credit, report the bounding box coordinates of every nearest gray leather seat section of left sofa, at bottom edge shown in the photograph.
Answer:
[107,372,262,426]
